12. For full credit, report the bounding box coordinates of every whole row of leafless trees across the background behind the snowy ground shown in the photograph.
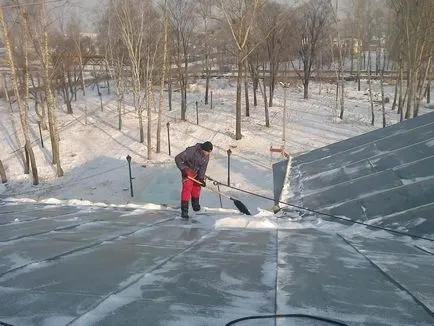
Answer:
[0,0,434,184]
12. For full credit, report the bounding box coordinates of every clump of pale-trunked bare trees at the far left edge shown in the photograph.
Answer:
[0,0,63,185]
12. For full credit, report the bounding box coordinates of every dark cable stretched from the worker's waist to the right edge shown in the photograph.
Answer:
[207,176,434,242]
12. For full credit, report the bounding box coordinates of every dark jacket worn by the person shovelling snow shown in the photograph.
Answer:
[175,143,209,179]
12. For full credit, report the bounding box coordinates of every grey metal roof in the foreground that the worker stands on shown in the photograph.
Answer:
[0,202,434,326]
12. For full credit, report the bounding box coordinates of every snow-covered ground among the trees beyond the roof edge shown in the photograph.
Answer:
[0,78,430,224]
